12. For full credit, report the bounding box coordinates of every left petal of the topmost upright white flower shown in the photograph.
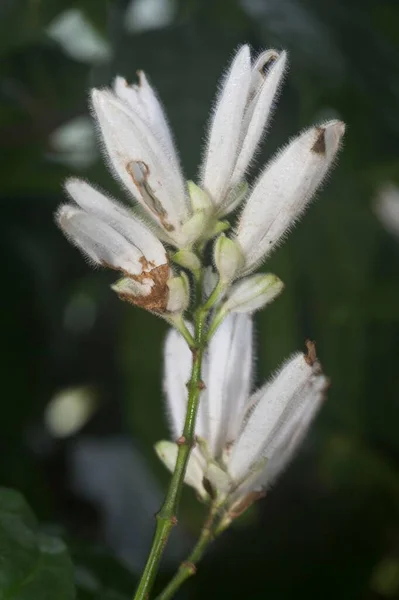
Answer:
[201,45,251,206]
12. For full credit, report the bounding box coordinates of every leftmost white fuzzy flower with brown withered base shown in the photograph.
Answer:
[56,179,183,313]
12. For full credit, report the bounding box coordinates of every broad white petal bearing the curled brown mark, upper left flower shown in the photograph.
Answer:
[92,90,189,237]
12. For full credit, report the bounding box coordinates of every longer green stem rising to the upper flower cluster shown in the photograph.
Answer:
[134,307,209,600]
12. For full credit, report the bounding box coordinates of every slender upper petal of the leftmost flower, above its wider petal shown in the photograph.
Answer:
[65,178,168,266]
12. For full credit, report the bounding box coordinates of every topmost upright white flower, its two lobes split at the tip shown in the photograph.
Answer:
[201,45,286,216]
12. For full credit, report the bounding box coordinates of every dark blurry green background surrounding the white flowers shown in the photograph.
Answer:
[0,0,399,600]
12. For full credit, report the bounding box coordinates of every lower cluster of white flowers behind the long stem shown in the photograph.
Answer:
[156,314,326,516]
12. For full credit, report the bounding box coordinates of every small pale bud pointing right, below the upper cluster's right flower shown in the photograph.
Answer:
[222,273,284,313]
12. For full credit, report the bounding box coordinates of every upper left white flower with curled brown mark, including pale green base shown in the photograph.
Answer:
[92,71,208,248]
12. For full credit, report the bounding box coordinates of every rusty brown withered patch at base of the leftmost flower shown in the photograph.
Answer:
[114,264,169,313]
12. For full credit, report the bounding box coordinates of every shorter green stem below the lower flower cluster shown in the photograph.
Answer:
[156,506,218,600]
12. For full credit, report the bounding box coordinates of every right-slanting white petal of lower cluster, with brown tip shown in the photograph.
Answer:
[229,354,324,481]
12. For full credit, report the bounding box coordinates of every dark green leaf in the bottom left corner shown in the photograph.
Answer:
[0,488,75,600]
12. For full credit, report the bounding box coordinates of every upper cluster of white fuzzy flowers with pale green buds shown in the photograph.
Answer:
[57,45,344,315]
